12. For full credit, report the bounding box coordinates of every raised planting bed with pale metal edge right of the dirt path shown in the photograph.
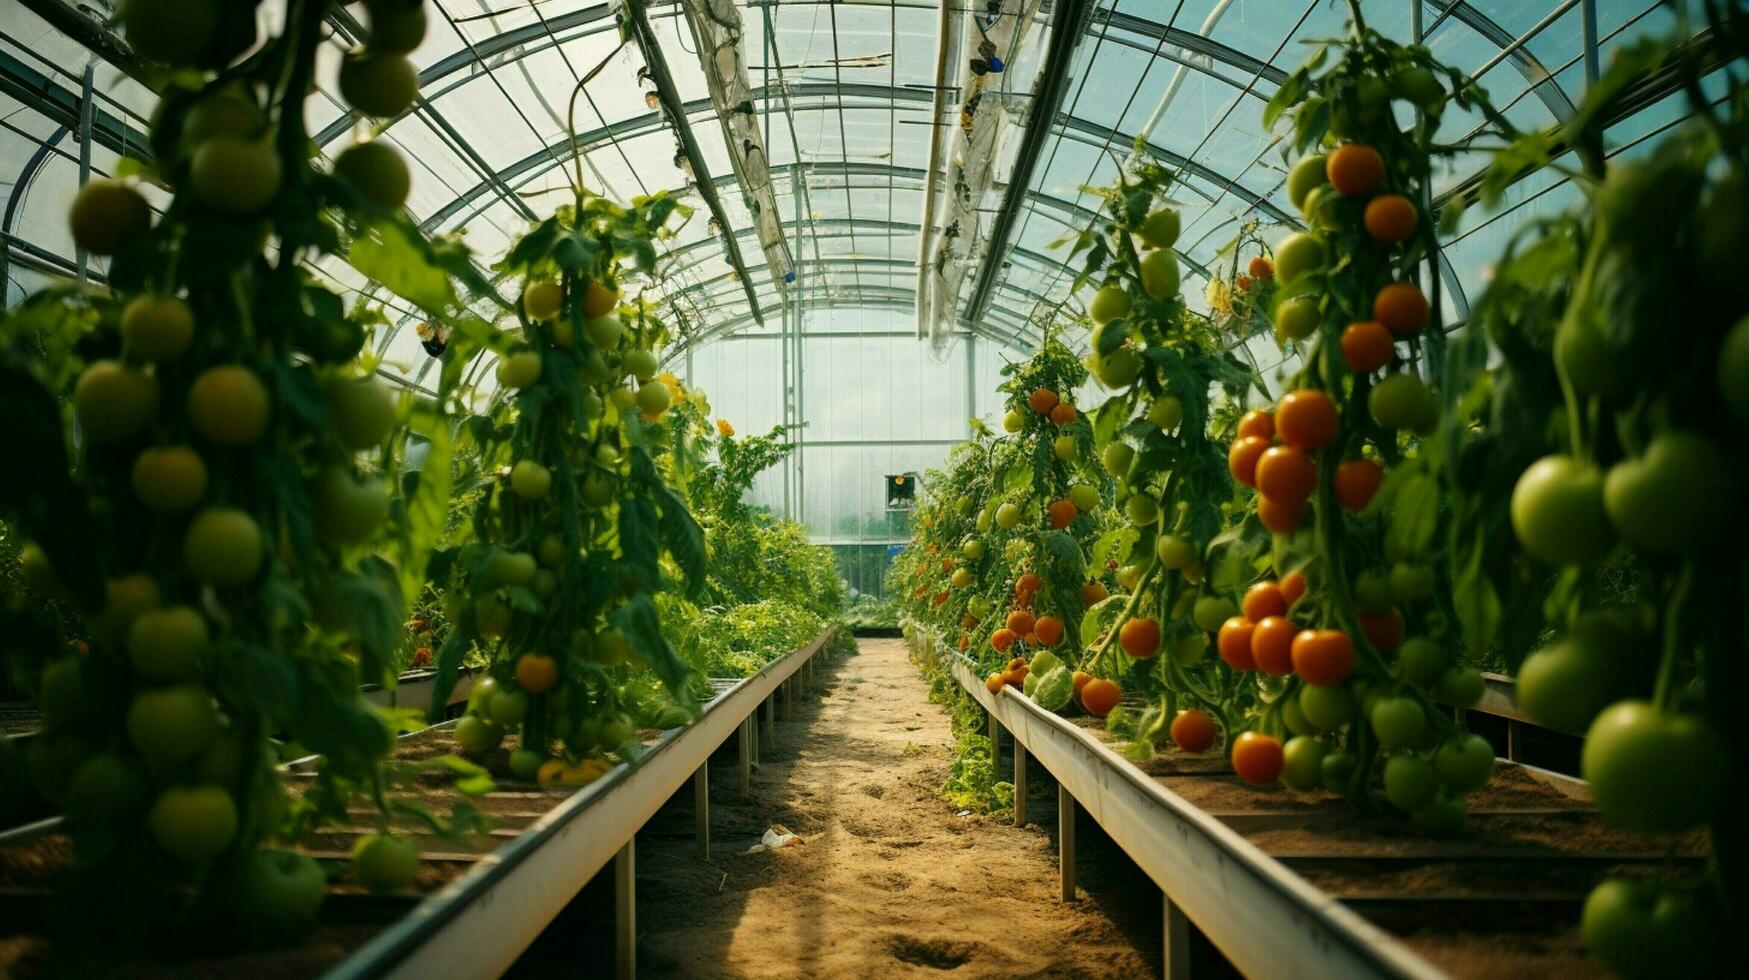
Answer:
[913,632,1705,978]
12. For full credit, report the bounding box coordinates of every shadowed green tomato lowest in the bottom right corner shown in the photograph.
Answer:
[1579,879,1719,980]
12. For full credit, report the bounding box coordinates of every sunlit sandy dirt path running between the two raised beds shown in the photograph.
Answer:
[638,639,1160,978]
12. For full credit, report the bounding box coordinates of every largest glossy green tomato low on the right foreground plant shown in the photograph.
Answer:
[1579,700,1732,833]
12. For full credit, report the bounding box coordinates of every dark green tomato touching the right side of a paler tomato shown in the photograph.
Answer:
[1604,432,1740,555]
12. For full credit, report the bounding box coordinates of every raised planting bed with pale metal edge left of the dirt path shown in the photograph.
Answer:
[0,634,827,977]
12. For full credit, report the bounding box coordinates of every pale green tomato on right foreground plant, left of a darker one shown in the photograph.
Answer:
[1511,457,1616,565]
